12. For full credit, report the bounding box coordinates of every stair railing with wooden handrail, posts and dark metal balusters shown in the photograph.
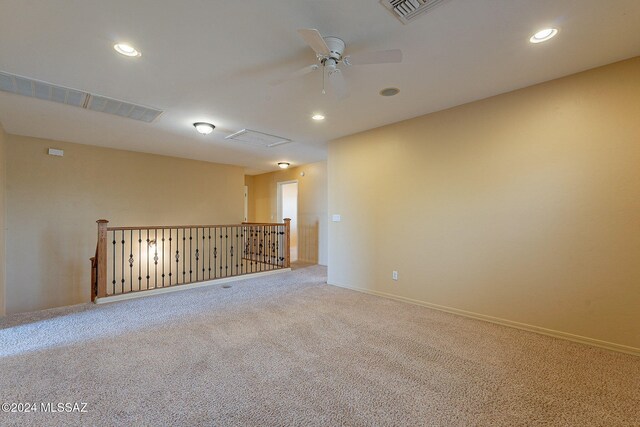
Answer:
[91,218,291,301]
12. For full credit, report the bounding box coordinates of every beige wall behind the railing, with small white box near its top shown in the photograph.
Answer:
[6,135,244,314]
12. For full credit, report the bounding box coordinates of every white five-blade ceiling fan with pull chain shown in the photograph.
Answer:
[272,29,402,99]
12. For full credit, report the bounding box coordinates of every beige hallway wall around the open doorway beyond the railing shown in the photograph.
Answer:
[245,162,327,265]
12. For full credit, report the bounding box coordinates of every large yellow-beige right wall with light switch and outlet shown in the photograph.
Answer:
[328,58,640,351]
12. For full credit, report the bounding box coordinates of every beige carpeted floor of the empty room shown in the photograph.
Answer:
[0,266,640,426]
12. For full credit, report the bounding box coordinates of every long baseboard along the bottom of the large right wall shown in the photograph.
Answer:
[327,282,640,357]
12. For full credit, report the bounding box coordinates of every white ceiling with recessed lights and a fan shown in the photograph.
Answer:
[0,0,640,173]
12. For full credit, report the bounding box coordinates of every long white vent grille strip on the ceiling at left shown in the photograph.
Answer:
[0,71,162,123]
